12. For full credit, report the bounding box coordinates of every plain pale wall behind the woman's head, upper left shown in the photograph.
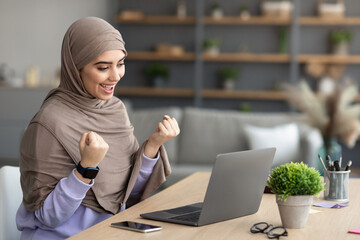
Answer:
[0,0,118,85]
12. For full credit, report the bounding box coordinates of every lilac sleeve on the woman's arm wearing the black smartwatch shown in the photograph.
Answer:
[35,169,94,227]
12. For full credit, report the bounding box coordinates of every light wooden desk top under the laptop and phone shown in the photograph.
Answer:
[69,173,360,240]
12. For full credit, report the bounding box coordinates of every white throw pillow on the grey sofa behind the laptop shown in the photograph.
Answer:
[244,123,300,166]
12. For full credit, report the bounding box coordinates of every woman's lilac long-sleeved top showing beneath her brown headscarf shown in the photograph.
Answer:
[16,153,160,240]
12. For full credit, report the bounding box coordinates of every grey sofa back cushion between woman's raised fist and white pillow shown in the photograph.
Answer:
[178,107,246,164]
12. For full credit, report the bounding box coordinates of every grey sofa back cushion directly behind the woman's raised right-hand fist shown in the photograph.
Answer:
[128,107,182,162]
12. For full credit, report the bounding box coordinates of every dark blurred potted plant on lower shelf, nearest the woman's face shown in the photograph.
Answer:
[145,63,169,87]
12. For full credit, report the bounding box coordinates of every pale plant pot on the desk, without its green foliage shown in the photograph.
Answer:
[276,195,313,228]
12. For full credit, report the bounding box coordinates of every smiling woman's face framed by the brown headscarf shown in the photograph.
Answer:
[80,50,125,100]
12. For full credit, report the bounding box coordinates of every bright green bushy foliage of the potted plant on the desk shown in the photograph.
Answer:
[266,162,324,201]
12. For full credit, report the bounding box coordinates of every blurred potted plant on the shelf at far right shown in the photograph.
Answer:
[329,29,353,55]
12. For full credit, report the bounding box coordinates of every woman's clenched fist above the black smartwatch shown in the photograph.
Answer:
[79,132,109,168]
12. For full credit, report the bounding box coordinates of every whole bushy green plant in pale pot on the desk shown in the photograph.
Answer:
[266,162,324,228]
